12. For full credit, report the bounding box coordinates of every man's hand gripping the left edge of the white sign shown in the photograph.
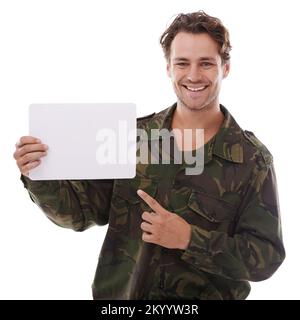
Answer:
[14,136,48,176]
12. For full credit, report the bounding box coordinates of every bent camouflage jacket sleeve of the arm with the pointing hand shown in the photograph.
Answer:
[181,164,285,281]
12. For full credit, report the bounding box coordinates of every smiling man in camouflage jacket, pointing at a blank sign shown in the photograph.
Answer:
[14,11,285,299]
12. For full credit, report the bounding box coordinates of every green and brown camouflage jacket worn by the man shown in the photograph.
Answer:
[22,104,285,300]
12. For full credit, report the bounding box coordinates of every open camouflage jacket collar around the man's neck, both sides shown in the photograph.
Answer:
[148,103,243,163]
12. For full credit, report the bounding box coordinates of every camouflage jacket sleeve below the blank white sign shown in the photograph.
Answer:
[21,175,114,231]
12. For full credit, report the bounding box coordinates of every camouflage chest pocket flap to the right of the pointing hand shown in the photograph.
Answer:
[186,191,237,231]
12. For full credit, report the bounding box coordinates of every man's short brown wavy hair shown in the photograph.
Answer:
[160,10,231,63]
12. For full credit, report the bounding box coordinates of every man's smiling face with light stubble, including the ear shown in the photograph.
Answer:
[167,32,229,111]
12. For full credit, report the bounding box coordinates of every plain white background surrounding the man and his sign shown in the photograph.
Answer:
[0,0,300,299]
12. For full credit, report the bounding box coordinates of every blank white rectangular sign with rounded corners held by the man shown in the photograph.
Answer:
[29,103,136,180]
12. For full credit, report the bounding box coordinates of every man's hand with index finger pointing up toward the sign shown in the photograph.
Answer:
[137,190,191,250]
